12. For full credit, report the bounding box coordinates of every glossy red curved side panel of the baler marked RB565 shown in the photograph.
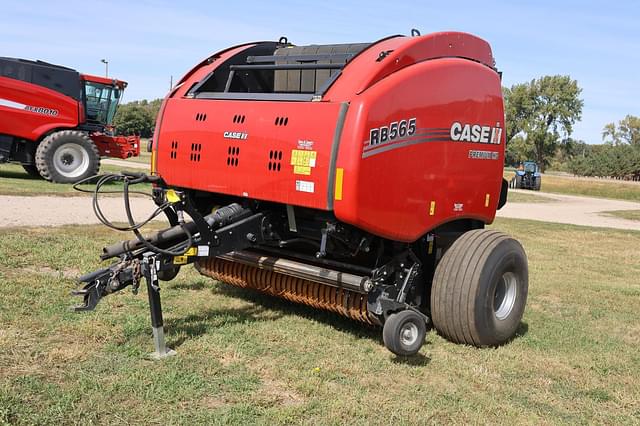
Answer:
[334,59,504,241]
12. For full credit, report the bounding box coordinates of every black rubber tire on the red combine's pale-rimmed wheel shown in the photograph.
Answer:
[36,130,100,183]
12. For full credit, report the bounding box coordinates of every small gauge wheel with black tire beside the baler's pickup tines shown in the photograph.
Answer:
[382,309,427,356]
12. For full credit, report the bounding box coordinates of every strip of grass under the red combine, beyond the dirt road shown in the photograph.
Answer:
[0,163,151,197]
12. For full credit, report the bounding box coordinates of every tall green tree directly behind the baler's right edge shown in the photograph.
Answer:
[504,75,584,171]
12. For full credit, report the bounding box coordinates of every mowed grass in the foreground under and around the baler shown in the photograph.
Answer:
[0,219,640,425]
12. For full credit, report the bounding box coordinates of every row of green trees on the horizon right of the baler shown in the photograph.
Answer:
[503,75,640,180]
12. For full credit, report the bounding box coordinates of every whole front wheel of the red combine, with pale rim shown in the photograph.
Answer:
[36,130,100,183]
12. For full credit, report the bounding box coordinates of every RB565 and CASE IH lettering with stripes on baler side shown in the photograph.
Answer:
[362,118,502,160]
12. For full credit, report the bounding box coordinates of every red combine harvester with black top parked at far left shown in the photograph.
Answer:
[0,57,140,183]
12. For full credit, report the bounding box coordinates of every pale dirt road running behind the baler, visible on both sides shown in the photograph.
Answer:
[0,190,640,231]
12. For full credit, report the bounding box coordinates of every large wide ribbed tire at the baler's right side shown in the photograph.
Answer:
[431,229,529,347]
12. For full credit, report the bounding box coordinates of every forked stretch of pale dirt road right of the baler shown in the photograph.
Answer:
[498,189,640,231]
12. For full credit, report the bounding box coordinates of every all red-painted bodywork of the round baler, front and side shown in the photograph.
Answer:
[154,32,504,241]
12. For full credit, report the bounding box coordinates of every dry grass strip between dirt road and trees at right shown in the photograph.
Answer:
[503,170,640,201]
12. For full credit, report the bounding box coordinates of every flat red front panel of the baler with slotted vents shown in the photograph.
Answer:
[157,98,340,210]
